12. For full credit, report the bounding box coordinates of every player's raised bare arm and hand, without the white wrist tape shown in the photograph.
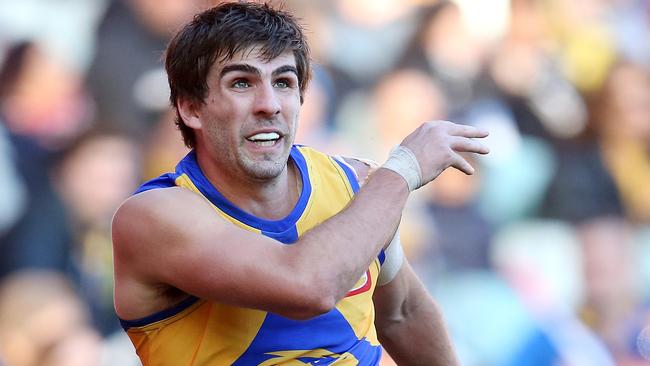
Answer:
[113,124,487,319]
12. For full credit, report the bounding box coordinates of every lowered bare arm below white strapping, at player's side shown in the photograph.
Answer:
[373,260,458,366]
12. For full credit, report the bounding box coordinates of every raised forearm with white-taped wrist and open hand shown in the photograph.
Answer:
[290,121,488,306]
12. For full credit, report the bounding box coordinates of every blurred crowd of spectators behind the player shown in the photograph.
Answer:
[0,0,650,366]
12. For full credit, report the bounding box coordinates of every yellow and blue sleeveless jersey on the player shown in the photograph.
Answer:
[121,146,384,366]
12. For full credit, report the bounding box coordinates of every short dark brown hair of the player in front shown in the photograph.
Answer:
[165,2,311,148]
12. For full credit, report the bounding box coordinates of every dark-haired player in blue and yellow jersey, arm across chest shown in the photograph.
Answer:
[113,3,487,365]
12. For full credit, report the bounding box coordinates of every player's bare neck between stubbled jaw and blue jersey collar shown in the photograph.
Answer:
[196,149,302,220]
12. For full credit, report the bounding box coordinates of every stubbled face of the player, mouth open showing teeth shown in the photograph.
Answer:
[195,48,300,180]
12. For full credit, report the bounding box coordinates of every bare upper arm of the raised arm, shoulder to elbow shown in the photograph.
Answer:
[113,188,308,310]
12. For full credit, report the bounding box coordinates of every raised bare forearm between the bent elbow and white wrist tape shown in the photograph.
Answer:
[291,169,408,303]
